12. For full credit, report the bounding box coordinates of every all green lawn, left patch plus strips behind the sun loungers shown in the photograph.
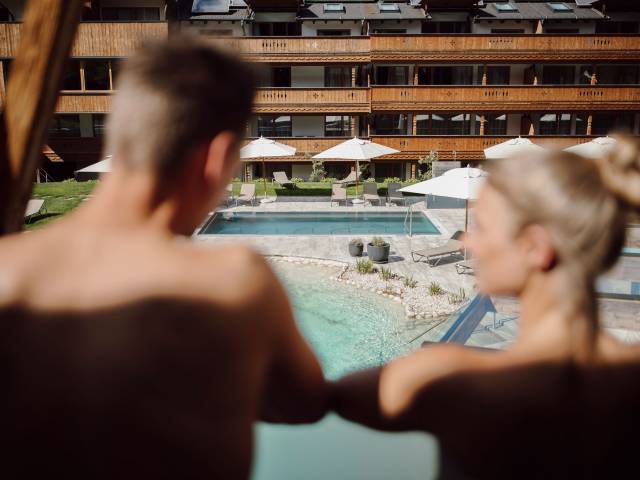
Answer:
[25,180,420,230]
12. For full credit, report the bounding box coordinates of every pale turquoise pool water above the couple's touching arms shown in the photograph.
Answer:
[274,263,426,379]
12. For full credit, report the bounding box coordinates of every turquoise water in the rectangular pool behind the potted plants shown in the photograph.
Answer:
[200,211,440,235]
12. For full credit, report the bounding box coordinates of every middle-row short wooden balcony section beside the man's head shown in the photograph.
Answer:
[253,88,371,113]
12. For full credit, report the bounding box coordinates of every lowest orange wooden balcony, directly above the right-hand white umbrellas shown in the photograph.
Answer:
[370,135,594,160]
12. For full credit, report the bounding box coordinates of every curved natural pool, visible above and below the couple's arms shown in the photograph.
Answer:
[252,263,438,480]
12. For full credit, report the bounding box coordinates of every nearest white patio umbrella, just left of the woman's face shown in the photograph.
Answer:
[400,167,488,232]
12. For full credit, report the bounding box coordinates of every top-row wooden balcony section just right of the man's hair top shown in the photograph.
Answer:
[210,37,370,64]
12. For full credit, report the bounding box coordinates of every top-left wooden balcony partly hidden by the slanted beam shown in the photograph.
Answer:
[0,22,168,57]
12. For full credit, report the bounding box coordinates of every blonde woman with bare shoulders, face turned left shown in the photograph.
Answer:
[333,141,640,479]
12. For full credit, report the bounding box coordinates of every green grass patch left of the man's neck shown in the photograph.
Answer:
[25,180,97,230]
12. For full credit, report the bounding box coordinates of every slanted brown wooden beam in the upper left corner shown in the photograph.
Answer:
[0,0,83,235]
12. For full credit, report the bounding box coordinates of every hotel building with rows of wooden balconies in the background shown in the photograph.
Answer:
[0,0,640,180]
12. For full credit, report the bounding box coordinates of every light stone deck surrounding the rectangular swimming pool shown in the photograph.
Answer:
[195,201,475,293]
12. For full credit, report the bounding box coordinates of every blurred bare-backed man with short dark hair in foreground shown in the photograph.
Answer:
[0,39,325,479]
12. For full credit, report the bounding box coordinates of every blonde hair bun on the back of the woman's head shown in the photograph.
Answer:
[597,137,640,209]
